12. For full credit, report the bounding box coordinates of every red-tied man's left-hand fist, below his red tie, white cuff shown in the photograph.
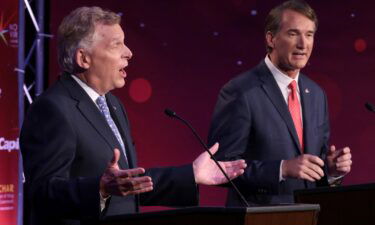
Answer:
[281,154,324,182]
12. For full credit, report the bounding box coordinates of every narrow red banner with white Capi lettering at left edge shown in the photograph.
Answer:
[0,0,19,225]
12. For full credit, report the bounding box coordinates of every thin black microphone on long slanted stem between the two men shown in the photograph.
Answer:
[164,109,250,207]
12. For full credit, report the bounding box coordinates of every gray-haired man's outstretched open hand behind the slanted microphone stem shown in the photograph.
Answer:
[193,143,246,185]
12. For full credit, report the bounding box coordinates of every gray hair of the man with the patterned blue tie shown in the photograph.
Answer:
[57,7,121,74]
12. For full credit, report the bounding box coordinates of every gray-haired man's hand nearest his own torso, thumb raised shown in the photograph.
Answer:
[100,149,153,198]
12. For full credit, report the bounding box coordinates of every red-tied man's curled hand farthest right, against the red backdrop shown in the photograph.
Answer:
[327,145,352,177]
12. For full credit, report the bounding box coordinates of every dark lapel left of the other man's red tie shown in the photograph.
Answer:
[258,62,301,153]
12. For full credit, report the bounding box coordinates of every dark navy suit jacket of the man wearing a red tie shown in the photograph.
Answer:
[208,61,329,205]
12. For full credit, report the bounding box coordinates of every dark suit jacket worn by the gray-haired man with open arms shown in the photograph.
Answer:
[20,74,198,225]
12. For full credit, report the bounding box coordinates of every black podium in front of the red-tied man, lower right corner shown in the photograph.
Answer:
[294,184,375,225]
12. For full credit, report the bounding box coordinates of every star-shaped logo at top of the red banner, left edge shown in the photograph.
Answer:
[0,12,18,47]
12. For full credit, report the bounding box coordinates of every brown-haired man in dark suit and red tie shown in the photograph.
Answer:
[209,1,352,206]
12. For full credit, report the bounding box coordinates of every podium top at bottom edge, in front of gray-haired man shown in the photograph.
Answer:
[101,204,319,225]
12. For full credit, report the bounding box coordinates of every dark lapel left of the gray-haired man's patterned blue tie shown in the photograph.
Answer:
[60,74,126,168]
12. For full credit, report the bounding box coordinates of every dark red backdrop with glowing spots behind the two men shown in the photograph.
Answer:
[49,0,375,211]
